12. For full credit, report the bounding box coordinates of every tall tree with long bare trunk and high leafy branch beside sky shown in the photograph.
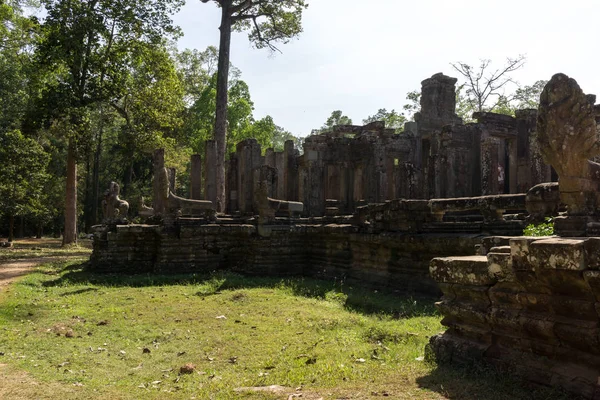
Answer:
[201,0,308,211]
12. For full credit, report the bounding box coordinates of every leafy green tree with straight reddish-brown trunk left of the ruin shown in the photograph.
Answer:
[38,0,182,244]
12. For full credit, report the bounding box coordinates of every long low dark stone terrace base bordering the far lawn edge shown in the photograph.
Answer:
[90,218,481,294]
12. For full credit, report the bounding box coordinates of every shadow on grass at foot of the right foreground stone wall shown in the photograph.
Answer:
[417,364,580,400]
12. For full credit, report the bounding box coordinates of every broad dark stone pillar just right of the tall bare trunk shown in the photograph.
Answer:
[236,139,262,214]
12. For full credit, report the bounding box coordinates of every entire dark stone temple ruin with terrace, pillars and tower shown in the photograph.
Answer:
[89,74,600,398]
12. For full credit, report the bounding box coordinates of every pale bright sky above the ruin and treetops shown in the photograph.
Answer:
[175,0,600,136]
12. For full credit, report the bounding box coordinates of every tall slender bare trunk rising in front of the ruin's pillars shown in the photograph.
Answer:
[214,0,231,212]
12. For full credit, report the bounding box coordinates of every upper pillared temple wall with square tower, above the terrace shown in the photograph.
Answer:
[191,74,552,217]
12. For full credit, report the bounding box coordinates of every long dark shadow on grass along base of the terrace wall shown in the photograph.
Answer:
[42,263,438,319]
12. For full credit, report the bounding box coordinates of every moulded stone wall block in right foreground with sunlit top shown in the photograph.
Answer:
[430,237,600,398]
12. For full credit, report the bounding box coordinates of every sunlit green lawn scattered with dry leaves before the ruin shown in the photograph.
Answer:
[0,259,568,400]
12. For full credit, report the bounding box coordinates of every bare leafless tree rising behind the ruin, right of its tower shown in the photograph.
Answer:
[450,55,525,112]
